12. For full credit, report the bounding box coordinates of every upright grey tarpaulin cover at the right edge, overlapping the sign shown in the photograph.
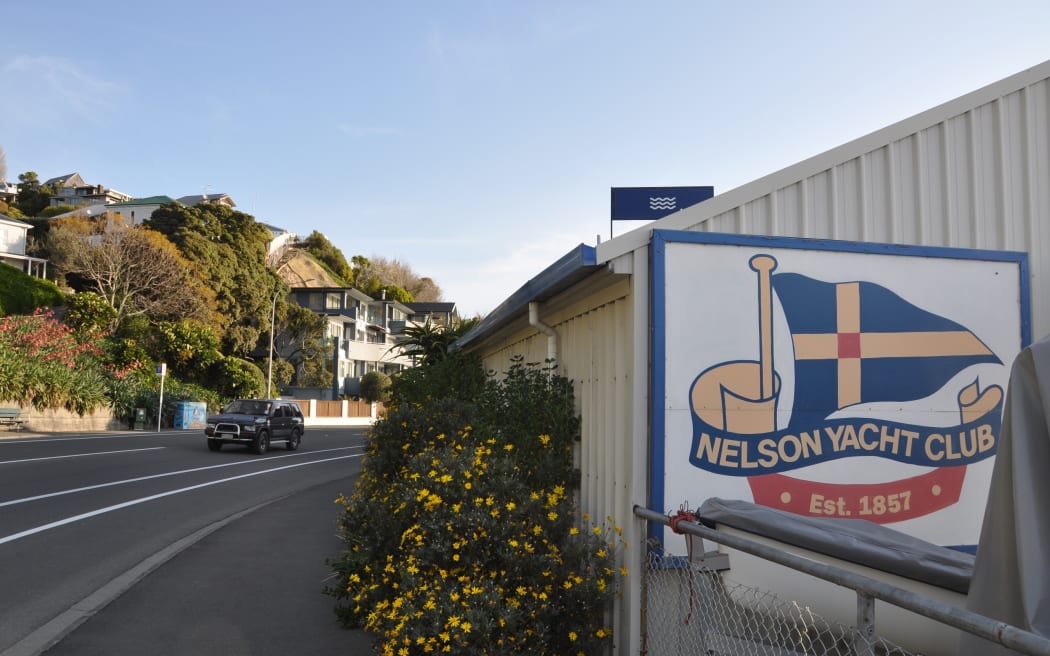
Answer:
[960,339,1050,656]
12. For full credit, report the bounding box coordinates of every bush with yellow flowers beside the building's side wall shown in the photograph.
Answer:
[327,354,624,656]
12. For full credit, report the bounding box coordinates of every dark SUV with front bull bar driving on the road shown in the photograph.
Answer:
[204,399,303,454]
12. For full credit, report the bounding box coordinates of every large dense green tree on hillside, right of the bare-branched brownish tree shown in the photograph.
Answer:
[143,203,287,356]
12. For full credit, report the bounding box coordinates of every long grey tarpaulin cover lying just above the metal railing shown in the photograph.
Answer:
[698,499,973,594]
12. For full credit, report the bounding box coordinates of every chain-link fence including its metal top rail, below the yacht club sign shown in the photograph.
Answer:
[634,506,1050,656]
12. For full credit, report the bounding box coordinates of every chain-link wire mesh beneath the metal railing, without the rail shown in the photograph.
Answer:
[643,550,912,656]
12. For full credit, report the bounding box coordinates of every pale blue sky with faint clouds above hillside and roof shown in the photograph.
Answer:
[0,0,1050,316]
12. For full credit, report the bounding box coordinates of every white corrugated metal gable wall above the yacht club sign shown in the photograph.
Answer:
[660,62,1050,339]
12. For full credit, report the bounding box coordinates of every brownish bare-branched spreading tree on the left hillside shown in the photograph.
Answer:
[48,219,210,332]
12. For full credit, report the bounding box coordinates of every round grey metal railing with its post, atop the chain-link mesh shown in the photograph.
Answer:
[634,506,1050,656]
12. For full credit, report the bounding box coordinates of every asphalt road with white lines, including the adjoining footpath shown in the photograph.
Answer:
[0,427,371,656]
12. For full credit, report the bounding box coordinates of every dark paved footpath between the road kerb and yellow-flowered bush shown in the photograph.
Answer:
[44,472,374,656]
